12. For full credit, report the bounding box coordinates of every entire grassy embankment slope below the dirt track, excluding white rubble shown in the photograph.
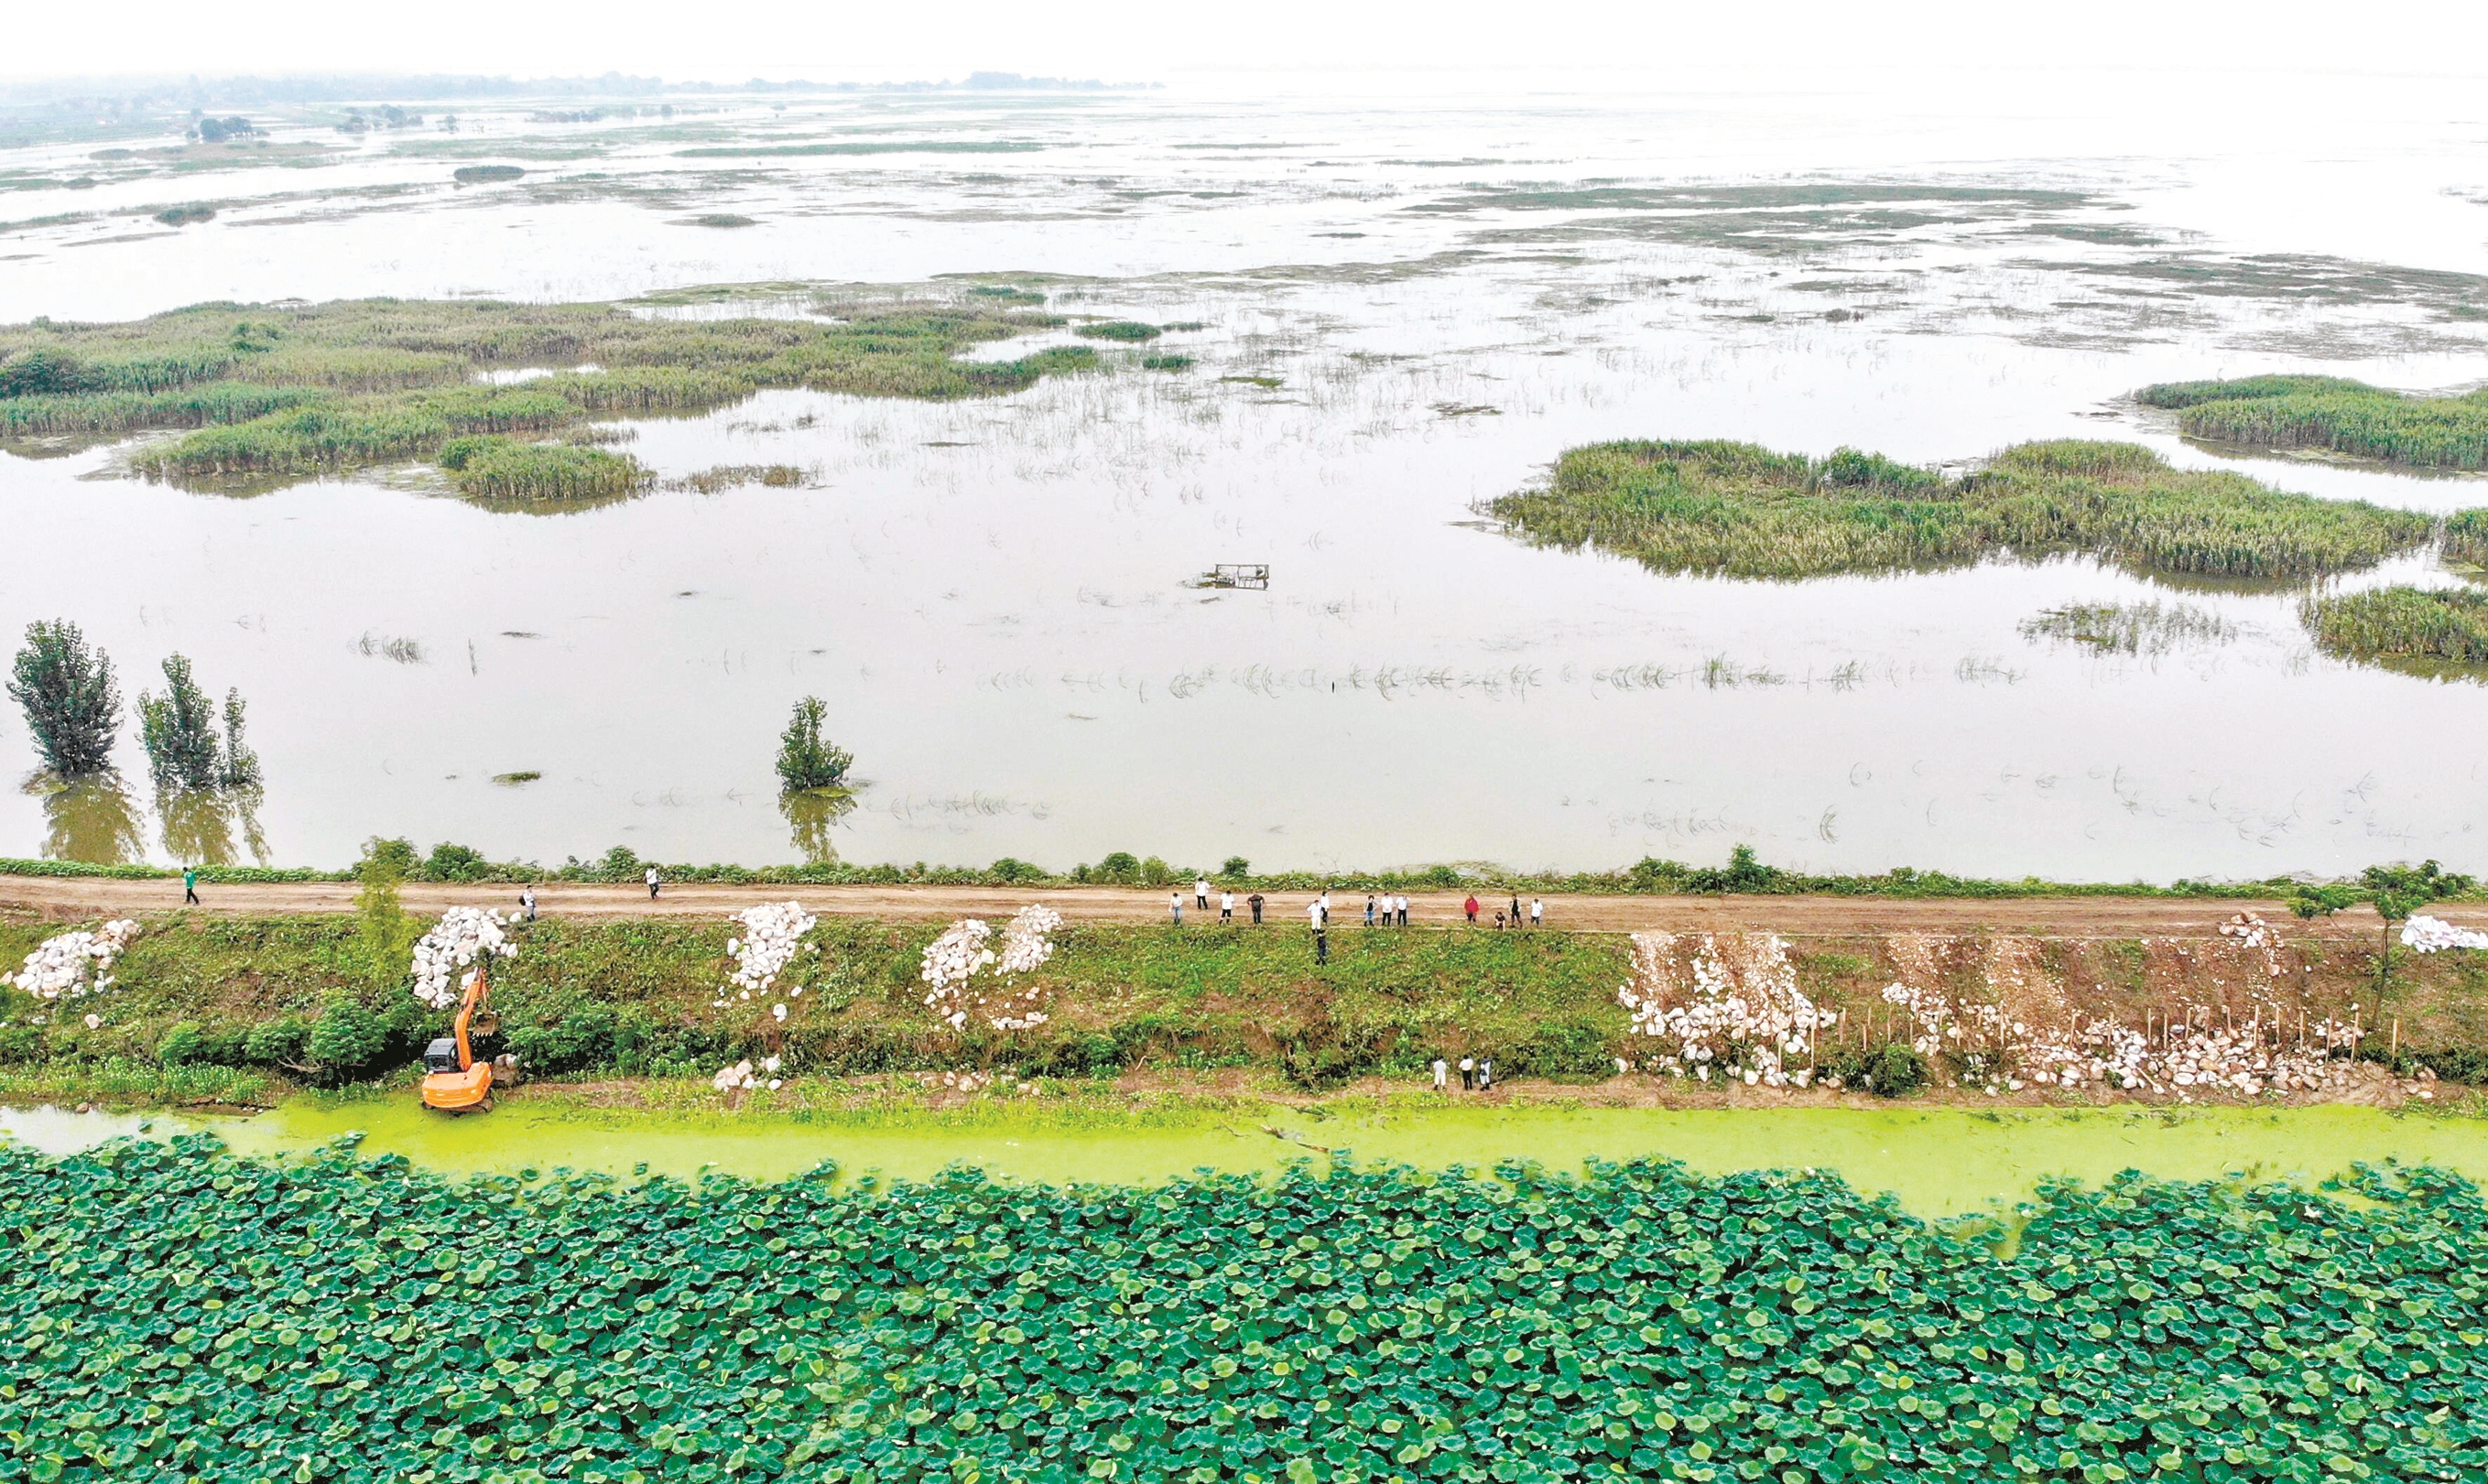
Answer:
[0,910,2488,1101]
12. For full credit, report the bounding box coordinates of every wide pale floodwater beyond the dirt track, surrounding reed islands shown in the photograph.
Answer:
[0,77,2488,880]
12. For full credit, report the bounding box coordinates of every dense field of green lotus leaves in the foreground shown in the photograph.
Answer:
[0,1139,2488,1484]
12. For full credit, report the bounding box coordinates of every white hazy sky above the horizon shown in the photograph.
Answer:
[14,0,2488,87]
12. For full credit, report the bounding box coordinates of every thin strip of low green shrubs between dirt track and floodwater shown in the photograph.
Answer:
[0,842,2408,894]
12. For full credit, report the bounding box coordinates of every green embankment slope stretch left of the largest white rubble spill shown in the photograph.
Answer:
[0,917,1630,1084]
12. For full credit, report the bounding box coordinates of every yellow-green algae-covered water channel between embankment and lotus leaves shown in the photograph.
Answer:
[0,1099,2488,1216]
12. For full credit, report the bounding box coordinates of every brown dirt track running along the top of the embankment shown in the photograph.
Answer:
[0,875,2448,937]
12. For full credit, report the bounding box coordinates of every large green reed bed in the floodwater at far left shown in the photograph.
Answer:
[0,296,1097,500]
